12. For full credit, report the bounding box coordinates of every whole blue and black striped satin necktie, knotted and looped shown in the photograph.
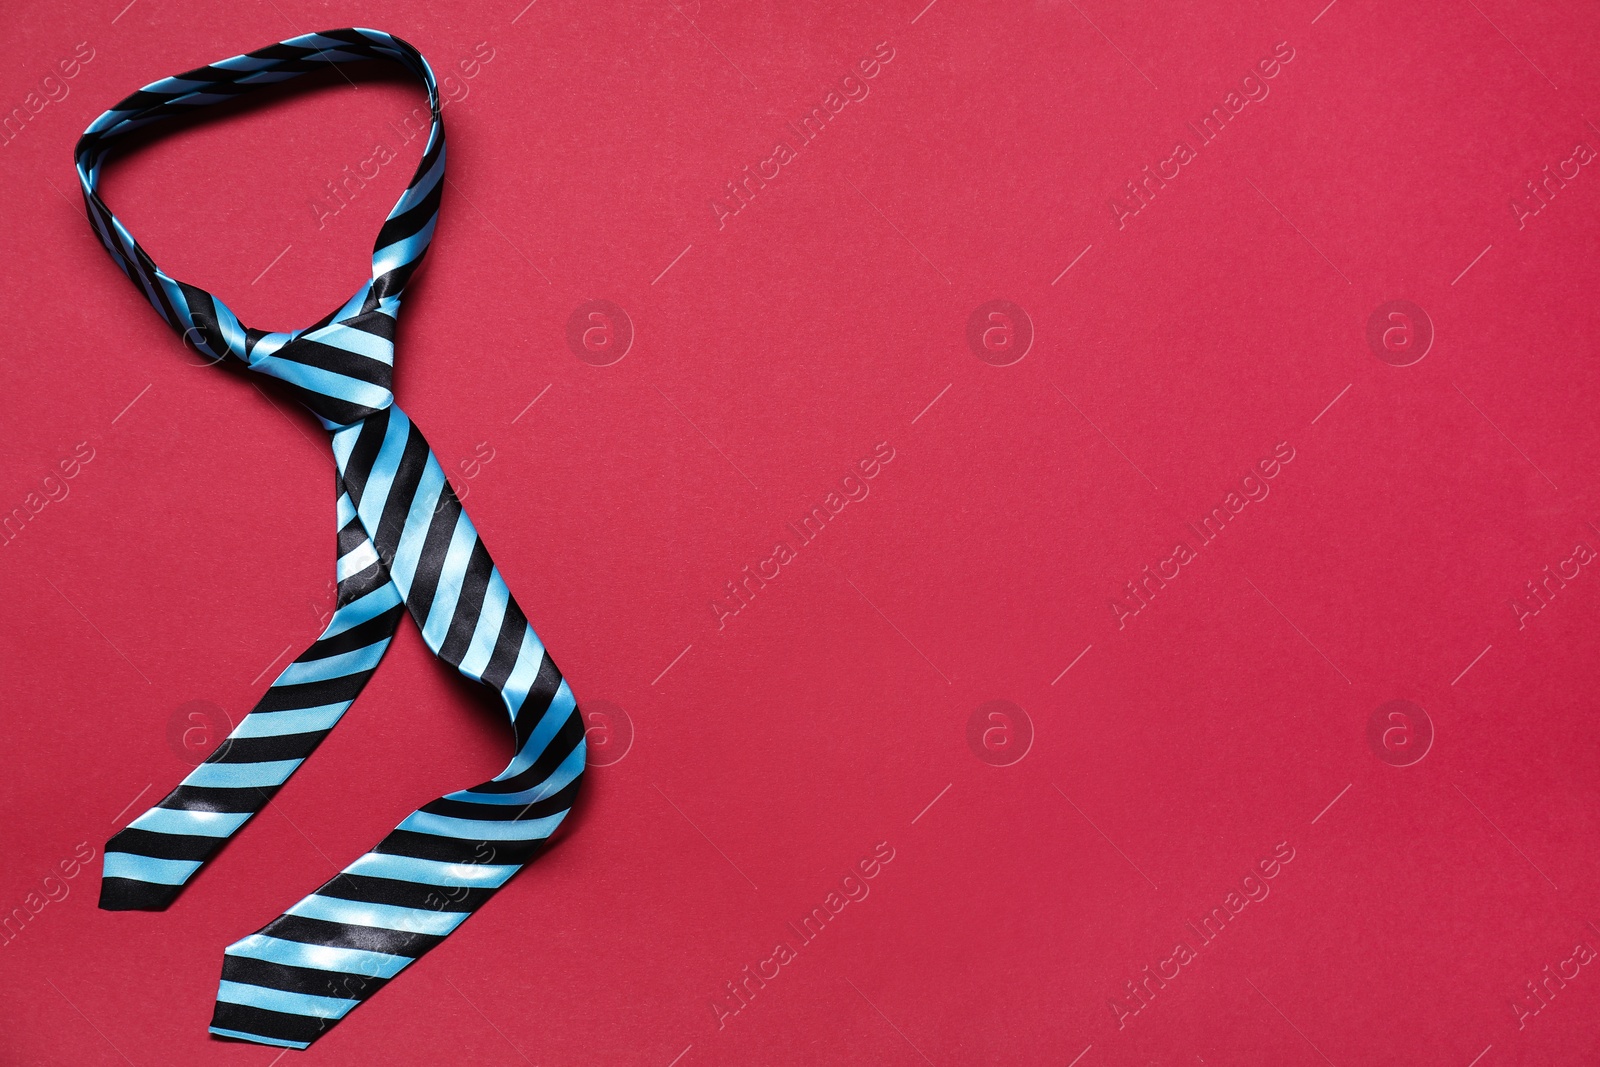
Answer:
[75,29,584,1048]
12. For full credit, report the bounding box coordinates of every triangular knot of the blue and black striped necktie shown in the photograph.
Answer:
[248,310,395,429]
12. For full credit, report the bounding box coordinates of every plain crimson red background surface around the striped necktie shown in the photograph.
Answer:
[0,0,1600,1067]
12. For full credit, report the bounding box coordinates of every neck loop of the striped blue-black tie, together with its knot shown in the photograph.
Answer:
[75,29,445,429]
